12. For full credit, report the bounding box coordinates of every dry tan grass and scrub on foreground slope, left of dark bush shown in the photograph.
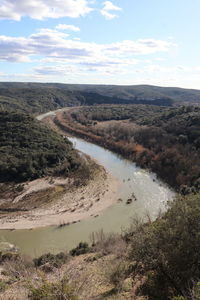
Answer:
[0,231,141,300]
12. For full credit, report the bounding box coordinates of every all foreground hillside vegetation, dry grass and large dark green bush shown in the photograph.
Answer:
[1,194,200,300]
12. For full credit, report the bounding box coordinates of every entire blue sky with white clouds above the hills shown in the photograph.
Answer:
[0,0,200,89]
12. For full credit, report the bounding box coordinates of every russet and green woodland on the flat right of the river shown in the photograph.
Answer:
[60,105,200,194]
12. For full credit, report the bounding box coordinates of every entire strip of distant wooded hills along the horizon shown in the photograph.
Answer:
[0,82,200,114]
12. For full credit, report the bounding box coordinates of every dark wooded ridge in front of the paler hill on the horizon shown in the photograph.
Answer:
[0,87,173,114]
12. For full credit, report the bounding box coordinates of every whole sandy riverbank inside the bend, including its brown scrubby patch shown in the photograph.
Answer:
[0,161,119,230]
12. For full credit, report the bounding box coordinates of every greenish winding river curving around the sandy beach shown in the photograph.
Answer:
[0,116,174,257]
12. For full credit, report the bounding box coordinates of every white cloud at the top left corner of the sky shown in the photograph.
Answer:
[0,0,92,21]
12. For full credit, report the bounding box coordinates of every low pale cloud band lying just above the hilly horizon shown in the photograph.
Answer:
[0,59,200,89]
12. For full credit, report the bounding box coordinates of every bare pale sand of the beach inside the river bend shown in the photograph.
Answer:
[0,168,119,229]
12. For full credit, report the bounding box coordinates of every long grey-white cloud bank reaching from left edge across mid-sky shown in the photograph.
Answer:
[0,28,173,65]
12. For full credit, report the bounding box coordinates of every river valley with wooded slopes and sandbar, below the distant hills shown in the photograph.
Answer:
[0,86,200,300]
